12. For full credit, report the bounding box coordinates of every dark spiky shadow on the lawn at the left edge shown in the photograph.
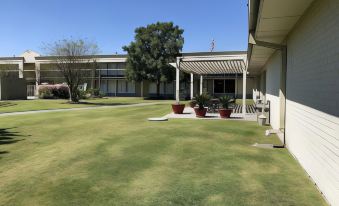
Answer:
[0,128,30,158]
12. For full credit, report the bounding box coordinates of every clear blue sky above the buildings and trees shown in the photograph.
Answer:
[0,0,247,56]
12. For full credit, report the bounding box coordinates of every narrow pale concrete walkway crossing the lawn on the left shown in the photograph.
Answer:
[0,103,157,117]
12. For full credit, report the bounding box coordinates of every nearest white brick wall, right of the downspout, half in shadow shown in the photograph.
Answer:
[286,0,339,205]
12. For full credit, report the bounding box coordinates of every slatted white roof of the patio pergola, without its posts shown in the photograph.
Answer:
[171,55,246,75]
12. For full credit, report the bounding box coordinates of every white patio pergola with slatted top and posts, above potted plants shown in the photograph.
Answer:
[170,54,247,115]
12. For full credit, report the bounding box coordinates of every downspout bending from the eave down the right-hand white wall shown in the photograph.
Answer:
[249,33,287,148]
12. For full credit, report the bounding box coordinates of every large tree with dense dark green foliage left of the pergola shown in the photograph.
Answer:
[123,22,184,97]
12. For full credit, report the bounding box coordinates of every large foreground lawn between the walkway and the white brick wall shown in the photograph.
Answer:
[0,105,325,206]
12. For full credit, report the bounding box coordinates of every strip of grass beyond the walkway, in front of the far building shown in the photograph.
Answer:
[0,97,174,113]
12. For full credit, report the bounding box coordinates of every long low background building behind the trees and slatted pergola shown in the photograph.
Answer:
[0,50,254,100]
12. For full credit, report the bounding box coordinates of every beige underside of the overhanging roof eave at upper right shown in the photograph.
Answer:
[248,0,313,74]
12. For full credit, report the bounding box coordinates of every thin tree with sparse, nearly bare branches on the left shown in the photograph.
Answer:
[46,39,98,102]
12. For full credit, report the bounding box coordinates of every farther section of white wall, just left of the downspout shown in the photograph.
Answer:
[265,51,282,129]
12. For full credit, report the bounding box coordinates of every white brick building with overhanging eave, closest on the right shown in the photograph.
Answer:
[248,0,339,205]
